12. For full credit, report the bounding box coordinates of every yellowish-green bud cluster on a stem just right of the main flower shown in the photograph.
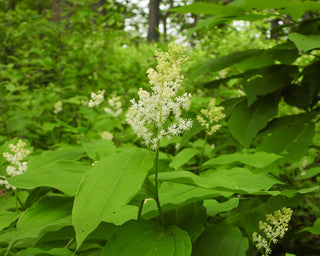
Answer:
[197,98,226,135]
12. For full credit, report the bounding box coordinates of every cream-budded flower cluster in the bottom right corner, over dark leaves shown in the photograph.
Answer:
[252,207,292,255]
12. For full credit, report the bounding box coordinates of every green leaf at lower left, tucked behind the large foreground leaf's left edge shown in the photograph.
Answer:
[15,196,72,240]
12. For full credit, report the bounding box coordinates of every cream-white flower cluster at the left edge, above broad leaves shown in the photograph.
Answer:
[0,140,31,189]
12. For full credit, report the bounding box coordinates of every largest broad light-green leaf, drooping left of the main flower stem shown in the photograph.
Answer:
[72,149,154,247]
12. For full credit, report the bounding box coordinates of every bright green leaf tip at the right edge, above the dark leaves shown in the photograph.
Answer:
[289,31,320,52]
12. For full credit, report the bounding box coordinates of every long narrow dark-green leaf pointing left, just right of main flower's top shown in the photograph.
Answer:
[190,50,261,79]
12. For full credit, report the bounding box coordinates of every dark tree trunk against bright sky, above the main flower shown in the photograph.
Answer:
[147,0,160,42]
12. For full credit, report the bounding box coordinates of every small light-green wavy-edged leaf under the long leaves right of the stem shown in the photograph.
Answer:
[203,198,239,216]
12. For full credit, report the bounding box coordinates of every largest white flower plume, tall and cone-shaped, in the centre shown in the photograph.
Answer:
[126,43,192,150]
